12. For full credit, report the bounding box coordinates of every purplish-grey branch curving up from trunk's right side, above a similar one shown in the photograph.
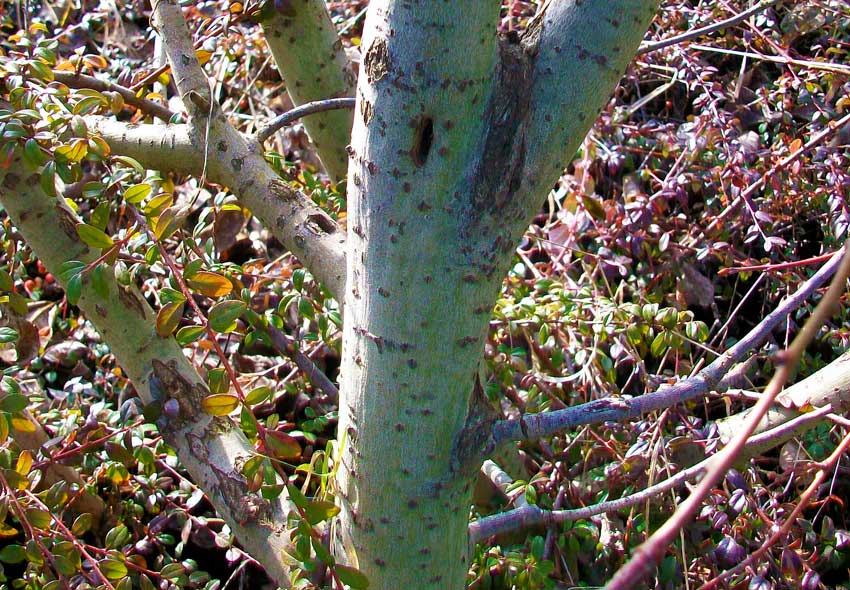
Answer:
[492,248,845,446]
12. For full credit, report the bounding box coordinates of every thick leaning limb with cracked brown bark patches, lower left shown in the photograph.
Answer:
[0,155,290,584]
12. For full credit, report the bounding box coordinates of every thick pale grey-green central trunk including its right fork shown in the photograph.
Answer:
[335,0,655,590]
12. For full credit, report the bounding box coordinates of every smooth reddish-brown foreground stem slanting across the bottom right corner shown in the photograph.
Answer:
[606,246,850,590]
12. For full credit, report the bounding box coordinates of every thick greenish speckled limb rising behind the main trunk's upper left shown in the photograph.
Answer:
[260,0,355,181]
